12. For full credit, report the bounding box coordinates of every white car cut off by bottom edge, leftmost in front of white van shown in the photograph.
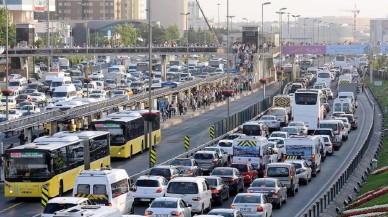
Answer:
[41,197,92,217]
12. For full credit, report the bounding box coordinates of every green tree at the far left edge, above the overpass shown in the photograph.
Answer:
[0,8,16,47]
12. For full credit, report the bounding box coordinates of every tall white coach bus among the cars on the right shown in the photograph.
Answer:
[292,89,324,132]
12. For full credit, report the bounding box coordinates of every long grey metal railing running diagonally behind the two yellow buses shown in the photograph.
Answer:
[0,75,227,132]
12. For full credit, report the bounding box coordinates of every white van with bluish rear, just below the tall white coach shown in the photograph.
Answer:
[284,136,324,176]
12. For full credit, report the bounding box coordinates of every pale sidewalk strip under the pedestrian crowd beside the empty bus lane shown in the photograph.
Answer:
[161,84,260,129]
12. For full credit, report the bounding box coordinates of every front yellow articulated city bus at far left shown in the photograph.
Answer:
[4,131,110,198]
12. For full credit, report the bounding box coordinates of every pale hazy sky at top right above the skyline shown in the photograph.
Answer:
[199,0,388,22]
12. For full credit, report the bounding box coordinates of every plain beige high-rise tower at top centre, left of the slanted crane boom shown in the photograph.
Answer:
[151,0,187,32]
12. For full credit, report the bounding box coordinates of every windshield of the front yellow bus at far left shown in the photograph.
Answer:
[5,153,50,181]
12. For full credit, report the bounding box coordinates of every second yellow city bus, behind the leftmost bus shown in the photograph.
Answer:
[91,110,161,158]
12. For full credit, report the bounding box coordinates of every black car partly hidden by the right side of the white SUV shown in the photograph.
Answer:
[202,176,229,205]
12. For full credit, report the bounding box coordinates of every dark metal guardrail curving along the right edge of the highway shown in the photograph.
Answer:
[296,88,376,217]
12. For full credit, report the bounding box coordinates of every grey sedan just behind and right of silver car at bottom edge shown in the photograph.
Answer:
[247,178,287,208]
